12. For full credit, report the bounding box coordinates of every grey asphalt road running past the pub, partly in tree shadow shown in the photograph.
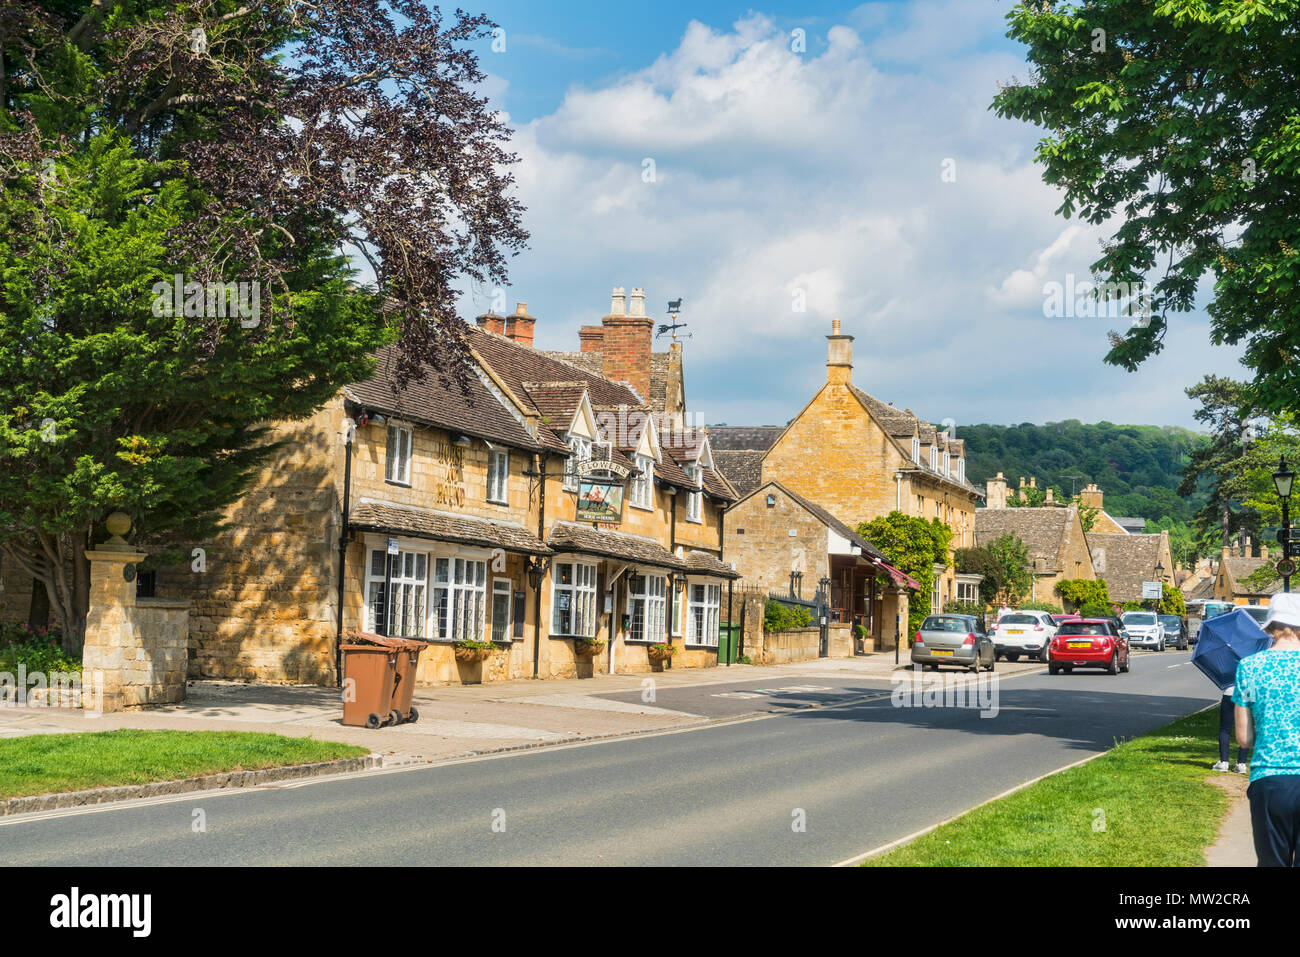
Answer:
[0,651,1218,866]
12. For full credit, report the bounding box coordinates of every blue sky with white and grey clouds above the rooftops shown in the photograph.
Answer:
[447,0,1245,426]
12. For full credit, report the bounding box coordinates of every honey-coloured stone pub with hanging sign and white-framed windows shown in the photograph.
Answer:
[83,287,738,685]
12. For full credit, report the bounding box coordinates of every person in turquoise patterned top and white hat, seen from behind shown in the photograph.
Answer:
[1232,593,1300,867]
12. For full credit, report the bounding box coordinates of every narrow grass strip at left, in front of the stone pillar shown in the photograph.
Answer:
[0,731,368,800]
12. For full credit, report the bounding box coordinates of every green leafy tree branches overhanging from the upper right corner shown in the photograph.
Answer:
[992,0,1300,411]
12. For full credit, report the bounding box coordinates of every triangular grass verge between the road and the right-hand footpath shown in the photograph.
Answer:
[862,709,1229,867]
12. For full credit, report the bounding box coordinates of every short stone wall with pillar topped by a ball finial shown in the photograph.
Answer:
[82,550,190,711]
